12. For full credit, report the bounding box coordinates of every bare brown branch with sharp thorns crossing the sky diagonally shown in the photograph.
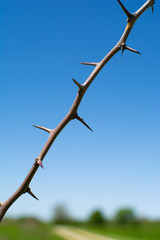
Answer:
[0,0,155,222]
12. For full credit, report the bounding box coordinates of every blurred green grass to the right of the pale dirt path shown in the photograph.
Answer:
[77,222,160,240]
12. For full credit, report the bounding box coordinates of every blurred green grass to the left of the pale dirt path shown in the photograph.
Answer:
[0,218,62,240]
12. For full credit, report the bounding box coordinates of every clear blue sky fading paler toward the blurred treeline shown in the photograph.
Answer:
[0,0,160,219]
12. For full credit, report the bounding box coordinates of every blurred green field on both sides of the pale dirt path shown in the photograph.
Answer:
[0,218,160,240]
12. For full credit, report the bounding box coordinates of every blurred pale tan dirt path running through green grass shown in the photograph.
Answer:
[53,226,118,240]
